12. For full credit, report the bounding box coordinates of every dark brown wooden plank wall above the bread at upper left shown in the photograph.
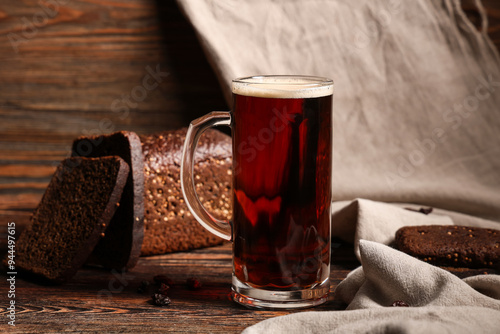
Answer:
[0,0,227,204]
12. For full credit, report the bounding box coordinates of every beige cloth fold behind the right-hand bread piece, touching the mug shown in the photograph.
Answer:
[332,199,500,259]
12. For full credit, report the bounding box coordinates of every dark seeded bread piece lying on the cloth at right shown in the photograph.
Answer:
[396,225,500,268]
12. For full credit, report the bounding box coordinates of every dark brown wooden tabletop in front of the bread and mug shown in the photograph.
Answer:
[0,240,359,333]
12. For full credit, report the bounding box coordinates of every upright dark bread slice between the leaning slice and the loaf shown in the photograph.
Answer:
[72,131,144,271]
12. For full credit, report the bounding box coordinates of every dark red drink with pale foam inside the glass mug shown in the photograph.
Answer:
[231,83,333,290]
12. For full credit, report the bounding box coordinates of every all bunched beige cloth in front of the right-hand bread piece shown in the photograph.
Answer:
[243,240,500,334]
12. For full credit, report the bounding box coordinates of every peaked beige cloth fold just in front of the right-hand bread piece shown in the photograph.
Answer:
[335,240,500,310]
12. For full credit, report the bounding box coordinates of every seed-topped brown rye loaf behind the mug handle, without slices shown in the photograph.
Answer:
[141,128,232,255]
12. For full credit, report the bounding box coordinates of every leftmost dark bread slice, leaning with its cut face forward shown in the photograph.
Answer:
[9,157,129,283]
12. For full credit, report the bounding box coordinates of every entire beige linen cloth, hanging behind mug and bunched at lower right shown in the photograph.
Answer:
[177,0,500,333]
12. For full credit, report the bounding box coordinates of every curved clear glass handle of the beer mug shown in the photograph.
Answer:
[181,111,232,240]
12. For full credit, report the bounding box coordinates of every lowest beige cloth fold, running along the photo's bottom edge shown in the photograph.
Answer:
[243,306,500,334]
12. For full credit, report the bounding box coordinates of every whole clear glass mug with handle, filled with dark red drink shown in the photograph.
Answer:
[181,76,333,309]
